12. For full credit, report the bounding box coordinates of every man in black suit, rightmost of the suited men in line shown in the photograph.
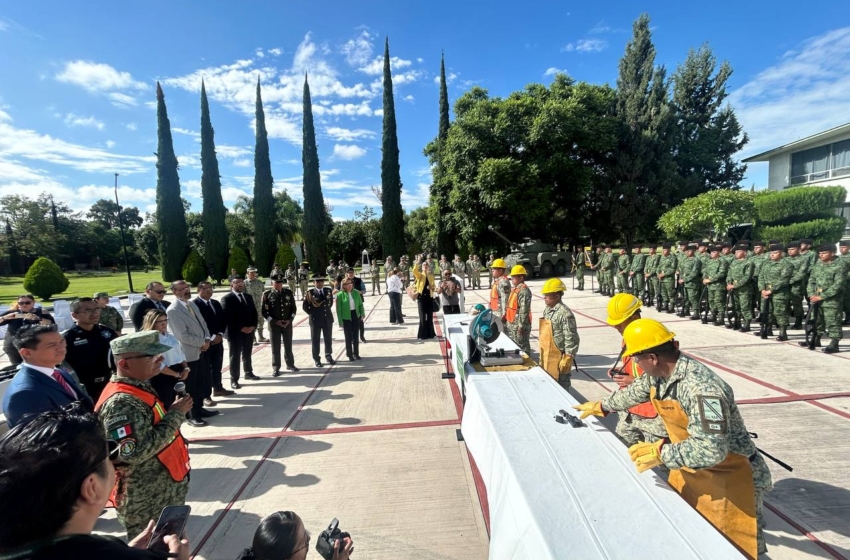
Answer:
[221,276,259,389]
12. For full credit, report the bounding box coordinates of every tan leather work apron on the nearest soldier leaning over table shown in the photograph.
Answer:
[650,387,758,559]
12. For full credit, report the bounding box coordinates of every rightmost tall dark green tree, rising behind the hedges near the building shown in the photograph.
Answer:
[672,45,748,199]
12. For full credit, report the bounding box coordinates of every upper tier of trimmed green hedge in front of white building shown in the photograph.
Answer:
[755,187,847,225]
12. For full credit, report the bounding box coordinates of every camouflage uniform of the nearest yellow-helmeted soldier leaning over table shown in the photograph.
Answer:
[602,354,773,552]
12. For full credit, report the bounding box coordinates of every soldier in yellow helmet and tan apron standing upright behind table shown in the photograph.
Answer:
[539,278,579,389]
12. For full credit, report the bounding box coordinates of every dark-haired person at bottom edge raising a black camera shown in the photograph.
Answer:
[239,511,354,560]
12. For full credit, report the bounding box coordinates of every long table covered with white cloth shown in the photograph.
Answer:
[447,321,742,560]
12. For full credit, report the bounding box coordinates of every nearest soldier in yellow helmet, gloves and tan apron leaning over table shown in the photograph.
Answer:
[575,319,773,559]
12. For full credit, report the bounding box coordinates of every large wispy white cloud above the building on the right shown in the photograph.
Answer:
[729,27,850,161]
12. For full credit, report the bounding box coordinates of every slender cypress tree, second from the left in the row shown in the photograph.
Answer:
[201,80,230,278]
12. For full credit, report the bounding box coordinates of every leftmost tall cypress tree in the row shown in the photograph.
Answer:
[156,82,189,282]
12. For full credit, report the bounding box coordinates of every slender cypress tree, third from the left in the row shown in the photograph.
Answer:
[254,78,276,276]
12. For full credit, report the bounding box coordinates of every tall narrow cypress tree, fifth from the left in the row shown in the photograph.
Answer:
[381,37,404,259]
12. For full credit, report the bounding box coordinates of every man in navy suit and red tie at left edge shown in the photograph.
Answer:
[3,325,94,428]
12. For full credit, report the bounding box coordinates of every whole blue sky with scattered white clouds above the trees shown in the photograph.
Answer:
[0,0,850,219]
